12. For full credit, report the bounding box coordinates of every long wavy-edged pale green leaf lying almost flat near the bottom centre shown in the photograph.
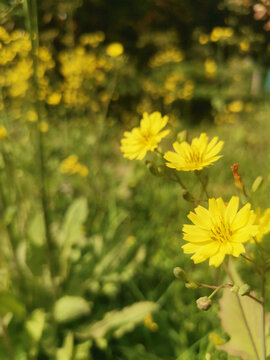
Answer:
[76,301,159,340]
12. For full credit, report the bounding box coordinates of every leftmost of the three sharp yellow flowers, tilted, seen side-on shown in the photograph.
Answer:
[121,111,170,160]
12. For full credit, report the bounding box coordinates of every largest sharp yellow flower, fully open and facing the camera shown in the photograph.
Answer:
[182,196,258,267]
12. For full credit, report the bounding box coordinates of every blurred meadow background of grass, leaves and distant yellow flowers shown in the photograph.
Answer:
[0,0,270,360]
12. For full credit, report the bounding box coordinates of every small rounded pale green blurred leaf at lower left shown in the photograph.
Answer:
[53,295,91,323]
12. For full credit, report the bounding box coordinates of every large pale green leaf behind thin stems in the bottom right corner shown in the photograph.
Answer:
[219,262,270,360]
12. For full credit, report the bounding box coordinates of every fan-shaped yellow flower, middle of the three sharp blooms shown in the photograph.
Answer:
[164,133,224,171]
